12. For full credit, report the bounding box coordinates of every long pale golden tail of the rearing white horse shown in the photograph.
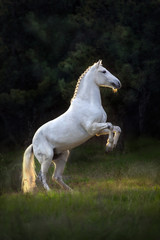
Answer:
[22,144,36,193]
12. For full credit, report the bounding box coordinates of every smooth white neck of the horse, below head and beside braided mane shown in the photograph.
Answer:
[76,74,101,105]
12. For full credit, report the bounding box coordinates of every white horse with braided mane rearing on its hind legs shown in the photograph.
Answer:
[22,60,121,192]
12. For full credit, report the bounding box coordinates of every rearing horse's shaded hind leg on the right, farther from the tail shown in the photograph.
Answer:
[52,151,72,191]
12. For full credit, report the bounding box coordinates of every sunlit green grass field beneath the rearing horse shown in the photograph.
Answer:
[0,139,160,240]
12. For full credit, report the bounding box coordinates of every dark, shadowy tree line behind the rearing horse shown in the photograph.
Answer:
[0,0,160,145]
